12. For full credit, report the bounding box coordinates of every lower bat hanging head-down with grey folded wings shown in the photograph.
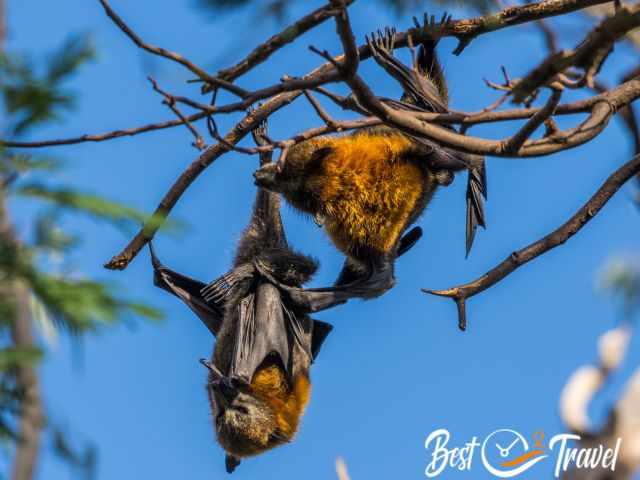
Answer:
[151,121,420,472]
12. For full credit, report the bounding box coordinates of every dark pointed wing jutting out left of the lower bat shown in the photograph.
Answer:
[149,242,224,335]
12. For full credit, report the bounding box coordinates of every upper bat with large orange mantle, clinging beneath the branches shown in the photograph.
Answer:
[254,15,486,311]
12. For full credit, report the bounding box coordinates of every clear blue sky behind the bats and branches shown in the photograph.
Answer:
[8,0,639,480]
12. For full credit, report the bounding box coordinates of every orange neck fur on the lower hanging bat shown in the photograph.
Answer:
[251,365,311,438]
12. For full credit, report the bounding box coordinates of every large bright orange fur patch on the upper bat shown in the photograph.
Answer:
[320,129,425,253]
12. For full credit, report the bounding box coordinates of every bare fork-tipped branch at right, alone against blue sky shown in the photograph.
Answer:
[423,155,640,330]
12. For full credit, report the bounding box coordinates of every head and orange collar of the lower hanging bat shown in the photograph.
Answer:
[209,358,311,470]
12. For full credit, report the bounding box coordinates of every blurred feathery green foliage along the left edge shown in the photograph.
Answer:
[0,26,162,472]
